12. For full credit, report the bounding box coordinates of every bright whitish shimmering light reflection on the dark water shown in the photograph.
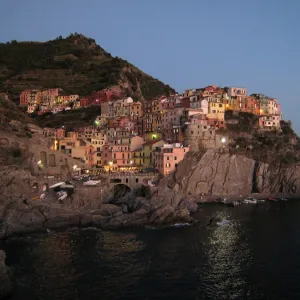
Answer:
[198,211,251,299]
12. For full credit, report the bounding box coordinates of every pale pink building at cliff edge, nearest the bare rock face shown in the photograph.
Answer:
[152,143,189,175]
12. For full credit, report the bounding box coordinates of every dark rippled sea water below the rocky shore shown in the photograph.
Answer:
[4,201,300,300]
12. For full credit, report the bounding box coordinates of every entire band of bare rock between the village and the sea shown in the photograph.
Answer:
[0,145,300,236]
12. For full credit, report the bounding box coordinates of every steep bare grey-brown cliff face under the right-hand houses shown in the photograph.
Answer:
[166,150,300,197]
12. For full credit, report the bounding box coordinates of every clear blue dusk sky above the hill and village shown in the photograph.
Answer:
[0,0,300,133]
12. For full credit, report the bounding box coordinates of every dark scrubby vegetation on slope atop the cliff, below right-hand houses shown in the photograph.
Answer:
[225,111,300,167]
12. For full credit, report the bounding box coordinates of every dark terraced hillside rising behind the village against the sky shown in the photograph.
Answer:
[0,34,174,99]
